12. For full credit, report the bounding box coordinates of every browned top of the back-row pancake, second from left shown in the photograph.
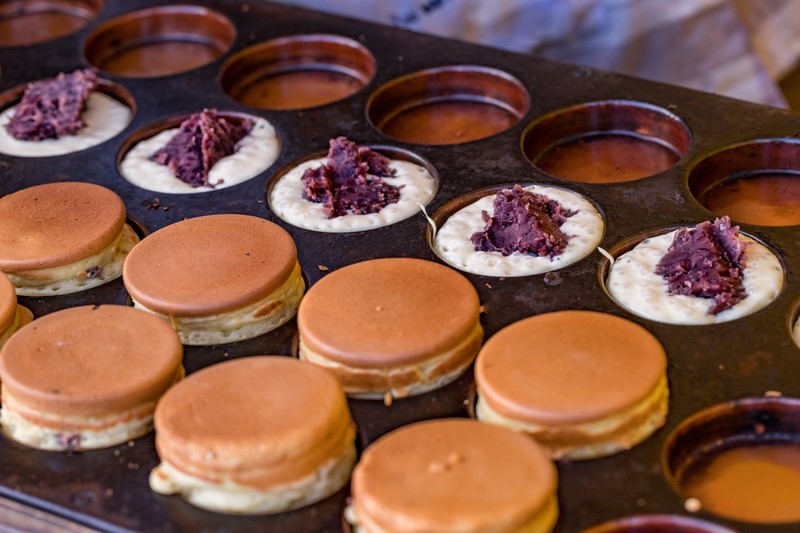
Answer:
[122,215,297,317]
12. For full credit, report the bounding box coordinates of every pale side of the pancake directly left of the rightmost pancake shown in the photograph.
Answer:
[298,322,483,400]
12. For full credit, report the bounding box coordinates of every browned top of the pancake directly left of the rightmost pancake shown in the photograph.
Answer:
[297,258,480,368]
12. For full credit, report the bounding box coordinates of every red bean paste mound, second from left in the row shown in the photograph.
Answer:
[152,109,253,187]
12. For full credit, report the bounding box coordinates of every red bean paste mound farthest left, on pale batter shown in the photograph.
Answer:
[6,69,97,141]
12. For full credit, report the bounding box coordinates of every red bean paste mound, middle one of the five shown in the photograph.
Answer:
[301,137,400,218]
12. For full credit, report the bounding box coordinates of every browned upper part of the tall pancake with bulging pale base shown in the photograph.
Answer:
[155,356,355,490]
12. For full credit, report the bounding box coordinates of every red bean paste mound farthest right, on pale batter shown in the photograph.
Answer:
[656,217,747,315]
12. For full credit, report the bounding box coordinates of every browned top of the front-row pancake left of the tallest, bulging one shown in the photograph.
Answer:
[0,305,183,416]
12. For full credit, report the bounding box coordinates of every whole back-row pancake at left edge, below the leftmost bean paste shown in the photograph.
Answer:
[0,182,138,296]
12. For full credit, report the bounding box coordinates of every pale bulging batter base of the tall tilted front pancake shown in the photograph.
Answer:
[150,445,356,514]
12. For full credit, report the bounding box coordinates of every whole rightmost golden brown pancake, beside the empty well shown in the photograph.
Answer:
[475,311,668,459]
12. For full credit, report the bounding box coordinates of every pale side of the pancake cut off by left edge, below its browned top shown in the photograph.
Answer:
[6,220,139,296]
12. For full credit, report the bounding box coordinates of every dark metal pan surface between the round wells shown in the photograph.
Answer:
[0,0,800,532]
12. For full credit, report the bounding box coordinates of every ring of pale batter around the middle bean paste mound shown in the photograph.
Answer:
[266,145,439,233]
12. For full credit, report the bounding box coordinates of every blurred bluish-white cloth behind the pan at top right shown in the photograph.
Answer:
[276,0,800,107]
